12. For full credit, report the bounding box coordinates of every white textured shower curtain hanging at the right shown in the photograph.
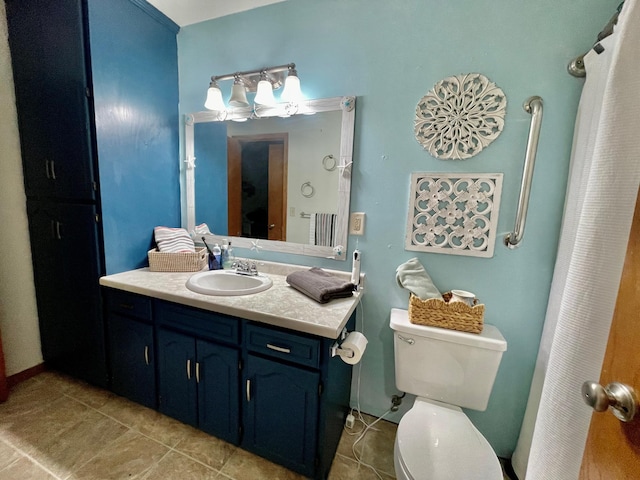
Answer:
[512,0,640,480]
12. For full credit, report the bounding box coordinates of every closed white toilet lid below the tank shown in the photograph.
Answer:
[396,398,503,480]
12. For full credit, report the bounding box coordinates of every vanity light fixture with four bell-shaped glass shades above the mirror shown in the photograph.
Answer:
[204,63,303,114]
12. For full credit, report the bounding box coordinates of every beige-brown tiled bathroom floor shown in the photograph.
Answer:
[0,372,396,480]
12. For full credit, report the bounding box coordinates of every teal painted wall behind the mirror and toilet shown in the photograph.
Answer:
[178,0,619,456]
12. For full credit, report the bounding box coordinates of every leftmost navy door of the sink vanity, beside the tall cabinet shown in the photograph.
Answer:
[107,313,156,408]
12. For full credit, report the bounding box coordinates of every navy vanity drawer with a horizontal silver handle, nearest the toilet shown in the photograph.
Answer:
[246,323,320,368]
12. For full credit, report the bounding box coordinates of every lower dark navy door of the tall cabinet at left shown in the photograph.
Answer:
[27,200,107,387]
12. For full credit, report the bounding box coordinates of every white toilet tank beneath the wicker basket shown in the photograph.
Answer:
[390,308,507,411]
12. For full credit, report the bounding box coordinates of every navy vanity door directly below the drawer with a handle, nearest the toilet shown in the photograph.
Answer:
[242,355,320,476]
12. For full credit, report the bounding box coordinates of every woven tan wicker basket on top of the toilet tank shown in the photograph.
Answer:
[409,293,484,333]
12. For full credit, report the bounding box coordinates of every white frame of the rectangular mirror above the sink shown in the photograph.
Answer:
[181,96,356,261]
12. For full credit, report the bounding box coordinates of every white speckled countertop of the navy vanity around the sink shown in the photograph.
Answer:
[100,262,364,338]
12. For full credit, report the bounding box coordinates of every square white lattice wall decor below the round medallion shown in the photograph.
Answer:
[405,173,502,257]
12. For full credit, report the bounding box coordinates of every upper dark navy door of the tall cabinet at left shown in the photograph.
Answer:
[6,0,96,200]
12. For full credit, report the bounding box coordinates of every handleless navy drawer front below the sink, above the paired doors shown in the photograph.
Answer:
[154,300,240,345]
